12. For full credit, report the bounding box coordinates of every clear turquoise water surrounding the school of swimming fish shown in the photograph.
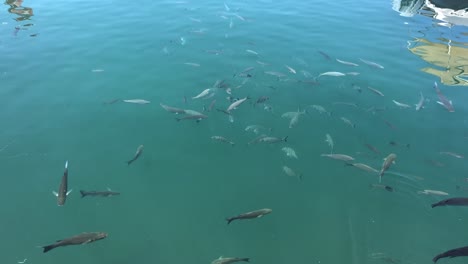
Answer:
[0,1,468,264]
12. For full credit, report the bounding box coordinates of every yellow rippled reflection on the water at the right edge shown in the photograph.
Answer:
[408,38,468,85]
